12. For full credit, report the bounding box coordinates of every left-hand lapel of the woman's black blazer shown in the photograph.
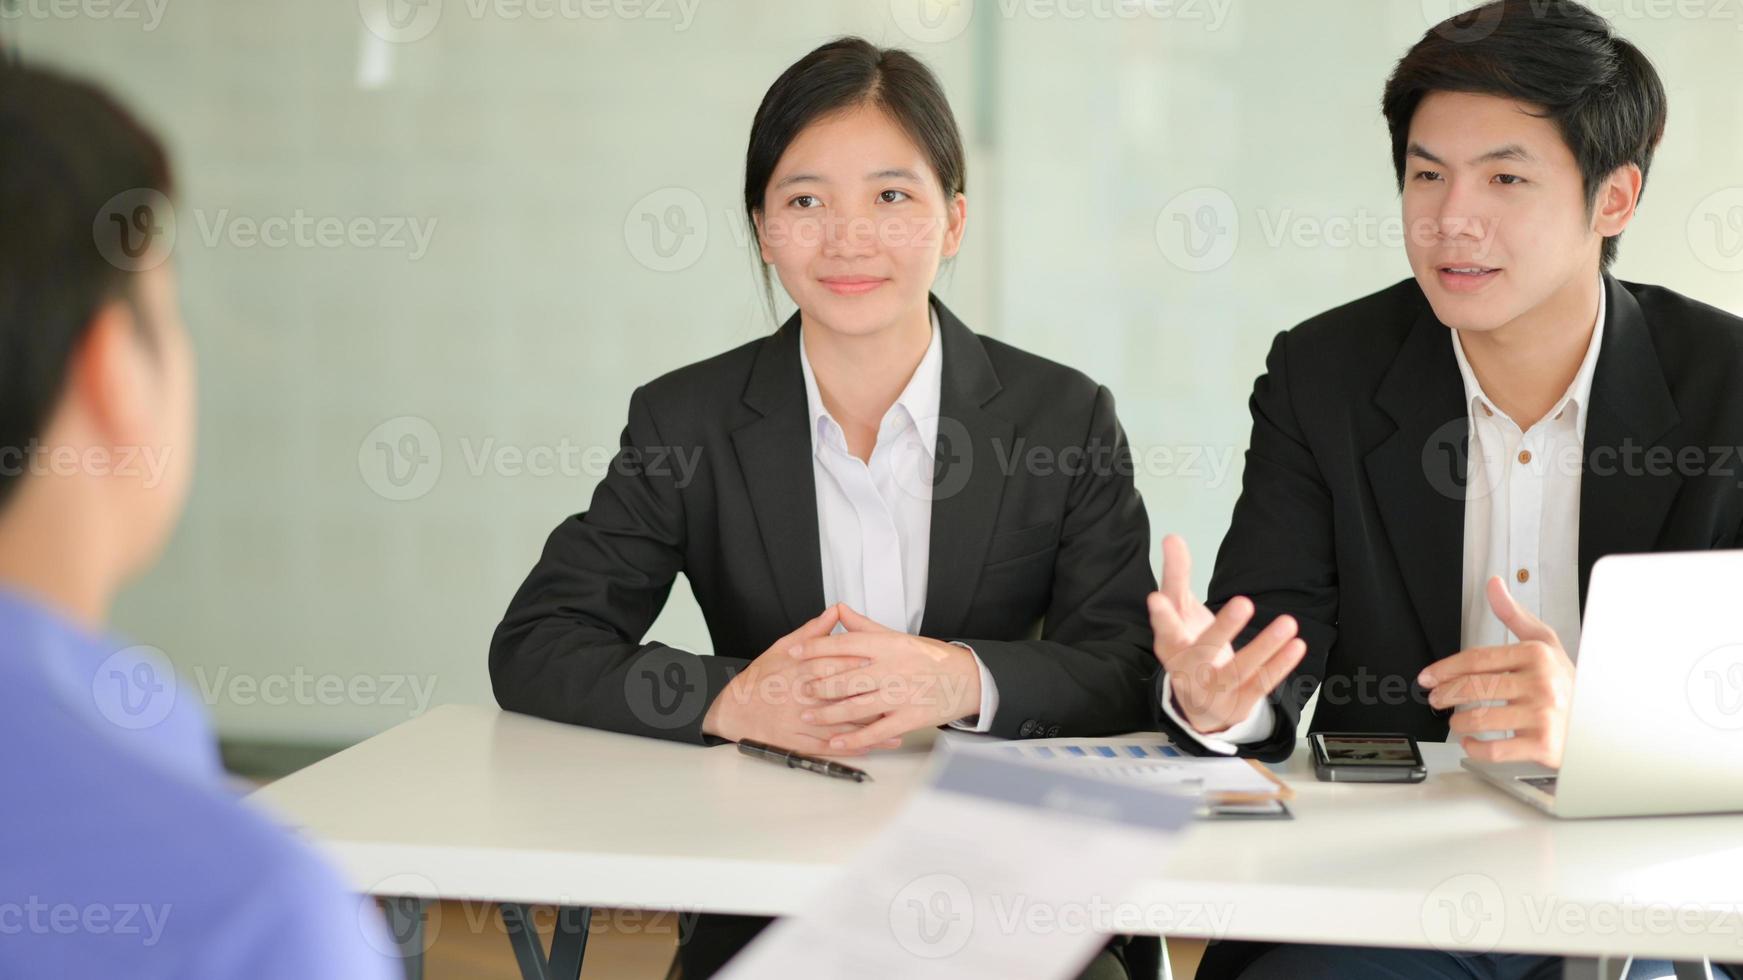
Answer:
[732,314,823,624]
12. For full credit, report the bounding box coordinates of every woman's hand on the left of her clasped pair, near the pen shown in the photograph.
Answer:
[702,605,899,755]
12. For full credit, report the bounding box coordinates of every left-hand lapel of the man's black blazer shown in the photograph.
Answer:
[1367,302,1469,659]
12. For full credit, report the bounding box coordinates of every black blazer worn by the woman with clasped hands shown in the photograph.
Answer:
[490,298,1156,743]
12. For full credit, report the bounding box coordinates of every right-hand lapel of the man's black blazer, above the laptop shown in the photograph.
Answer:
[1579,277,1682,610]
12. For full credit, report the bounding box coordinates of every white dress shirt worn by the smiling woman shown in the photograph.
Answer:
[798,312,999,732]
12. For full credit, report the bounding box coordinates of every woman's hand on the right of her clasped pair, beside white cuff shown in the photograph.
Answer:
[793,605,981,752]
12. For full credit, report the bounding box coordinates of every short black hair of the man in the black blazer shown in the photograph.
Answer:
[1380,0,1670,269]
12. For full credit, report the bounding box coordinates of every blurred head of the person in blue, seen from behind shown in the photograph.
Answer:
[0,66,193,606]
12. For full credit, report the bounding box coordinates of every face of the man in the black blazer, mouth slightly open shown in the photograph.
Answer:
[1403,92,1604,331]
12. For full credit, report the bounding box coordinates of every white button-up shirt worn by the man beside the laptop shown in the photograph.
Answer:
[1161,279,1609,755]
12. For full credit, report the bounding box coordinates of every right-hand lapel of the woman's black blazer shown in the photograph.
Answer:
[920,298,1016,636]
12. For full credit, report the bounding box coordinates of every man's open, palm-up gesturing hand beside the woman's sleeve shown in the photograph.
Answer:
[1150,534,1307,734]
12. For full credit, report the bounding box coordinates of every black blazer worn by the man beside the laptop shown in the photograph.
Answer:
[1157,277,1743,760]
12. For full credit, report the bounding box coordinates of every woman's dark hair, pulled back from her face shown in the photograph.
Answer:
[744,37,967,309]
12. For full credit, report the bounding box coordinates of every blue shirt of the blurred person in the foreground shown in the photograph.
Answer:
[0,589,396,980]
